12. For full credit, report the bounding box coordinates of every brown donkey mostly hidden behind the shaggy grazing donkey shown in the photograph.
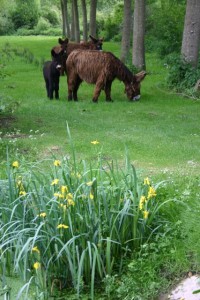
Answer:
[52,35,103,75]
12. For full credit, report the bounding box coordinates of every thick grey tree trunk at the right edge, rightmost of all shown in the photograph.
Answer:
[181,0,200,67]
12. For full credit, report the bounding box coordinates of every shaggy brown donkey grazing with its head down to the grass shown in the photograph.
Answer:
[66,50,146,102]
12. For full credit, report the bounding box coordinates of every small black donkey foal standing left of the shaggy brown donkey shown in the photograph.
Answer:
[43,50,63,99]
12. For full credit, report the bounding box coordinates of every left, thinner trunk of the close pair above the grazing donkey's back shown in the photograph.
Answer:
[121,0,132,62]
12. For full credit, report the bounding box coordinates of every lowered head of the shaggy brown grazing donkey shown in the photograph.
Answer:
[125,71,146,101]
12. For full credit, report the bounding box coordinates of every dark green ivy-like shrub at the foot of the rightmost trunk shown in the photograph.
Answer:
[166,54,200,97]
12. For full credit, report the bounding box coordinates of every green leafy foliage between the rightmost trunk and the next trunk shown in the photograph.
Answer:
[146,1,185,57]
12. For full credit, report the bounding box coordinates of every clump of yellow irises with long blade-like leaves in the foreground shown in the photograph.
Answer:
[0,130,180,299]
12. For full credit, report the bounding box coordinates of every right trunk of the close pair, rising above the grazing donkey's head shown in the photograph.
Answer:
[133,0,146,70]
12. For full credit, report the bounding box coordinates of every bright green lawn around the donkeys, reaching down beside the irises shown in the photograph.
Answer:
[0,36,200,300]
